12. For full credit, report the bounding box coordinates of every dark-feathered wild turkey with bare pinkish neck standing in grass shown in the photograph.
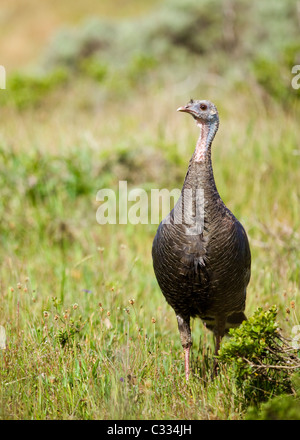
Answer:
[152,99,251,380]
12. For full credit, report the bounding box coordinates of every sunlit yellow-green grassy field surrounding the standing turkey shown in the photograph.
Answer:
[0,0,300,419]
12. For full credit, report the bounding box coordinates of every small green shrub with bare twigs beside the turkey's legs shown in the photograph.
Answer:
[219,306,300,405]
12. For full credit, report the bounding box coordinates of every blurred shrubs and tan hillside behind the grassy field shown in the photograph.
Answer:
[0,0,300,106]
